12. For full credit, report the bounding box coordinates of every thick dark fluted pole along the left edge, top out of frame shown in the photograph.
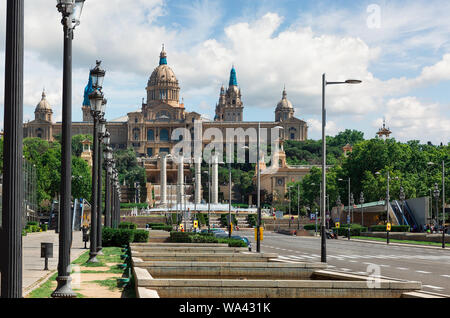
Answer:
[0,0,24,298]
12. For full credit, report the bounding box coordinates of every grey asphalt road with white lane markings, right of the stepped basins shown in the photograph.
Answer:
[241,231,450,295]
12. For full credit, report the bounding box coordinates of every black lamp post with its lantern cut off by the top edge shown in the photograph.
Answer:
[52,0,84,298]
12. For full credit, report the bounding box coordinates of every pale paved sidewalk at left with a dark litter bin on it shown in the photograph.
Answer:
[0,230,89,297]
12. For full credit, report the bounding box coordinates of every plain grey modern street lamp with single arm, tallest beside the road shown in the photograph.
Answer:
[320,74,361,263]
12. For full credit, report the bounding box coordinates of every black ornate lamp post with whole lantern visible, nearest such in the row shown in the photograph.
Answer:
[88,61,105,263]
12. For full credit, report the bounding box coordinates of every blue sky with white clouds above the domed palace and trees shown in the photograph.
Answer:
[0,0,450,144]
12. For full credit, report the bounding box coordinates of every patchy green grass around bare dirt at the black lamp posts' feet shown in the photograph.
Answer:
[27,247,135,298]
